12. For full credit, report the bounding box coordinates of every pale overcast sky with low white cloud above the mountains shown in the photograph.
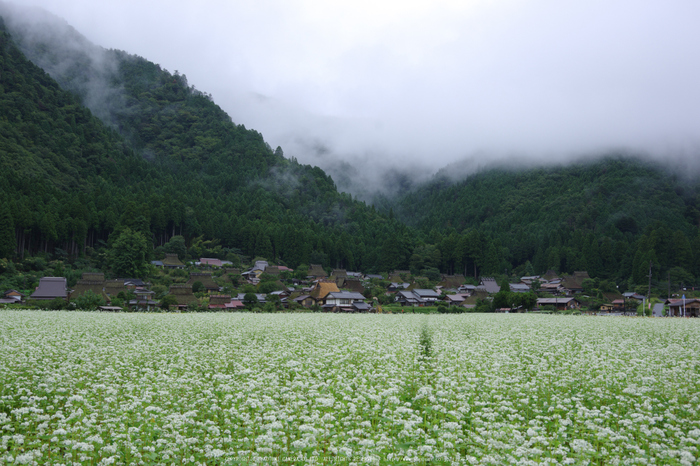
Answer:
[19,0,700,174]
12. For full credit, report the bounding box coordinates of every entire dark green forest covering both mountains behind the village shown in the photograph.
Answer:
[0,8,700,289]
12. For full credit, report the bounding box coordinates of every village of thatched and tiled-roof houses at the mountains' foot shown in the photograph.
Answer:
[0,254,700,317]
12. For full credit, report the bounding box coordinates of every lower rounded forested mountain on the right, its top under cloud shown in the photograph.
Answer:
[392,155,700,283]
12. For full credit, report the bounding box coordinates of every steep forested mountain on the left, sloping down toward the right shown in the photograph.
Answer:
[0,12,407,269]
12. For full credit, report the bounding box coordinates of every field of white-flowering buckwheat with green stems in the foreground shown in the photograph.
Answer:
[0,311,700,465]
